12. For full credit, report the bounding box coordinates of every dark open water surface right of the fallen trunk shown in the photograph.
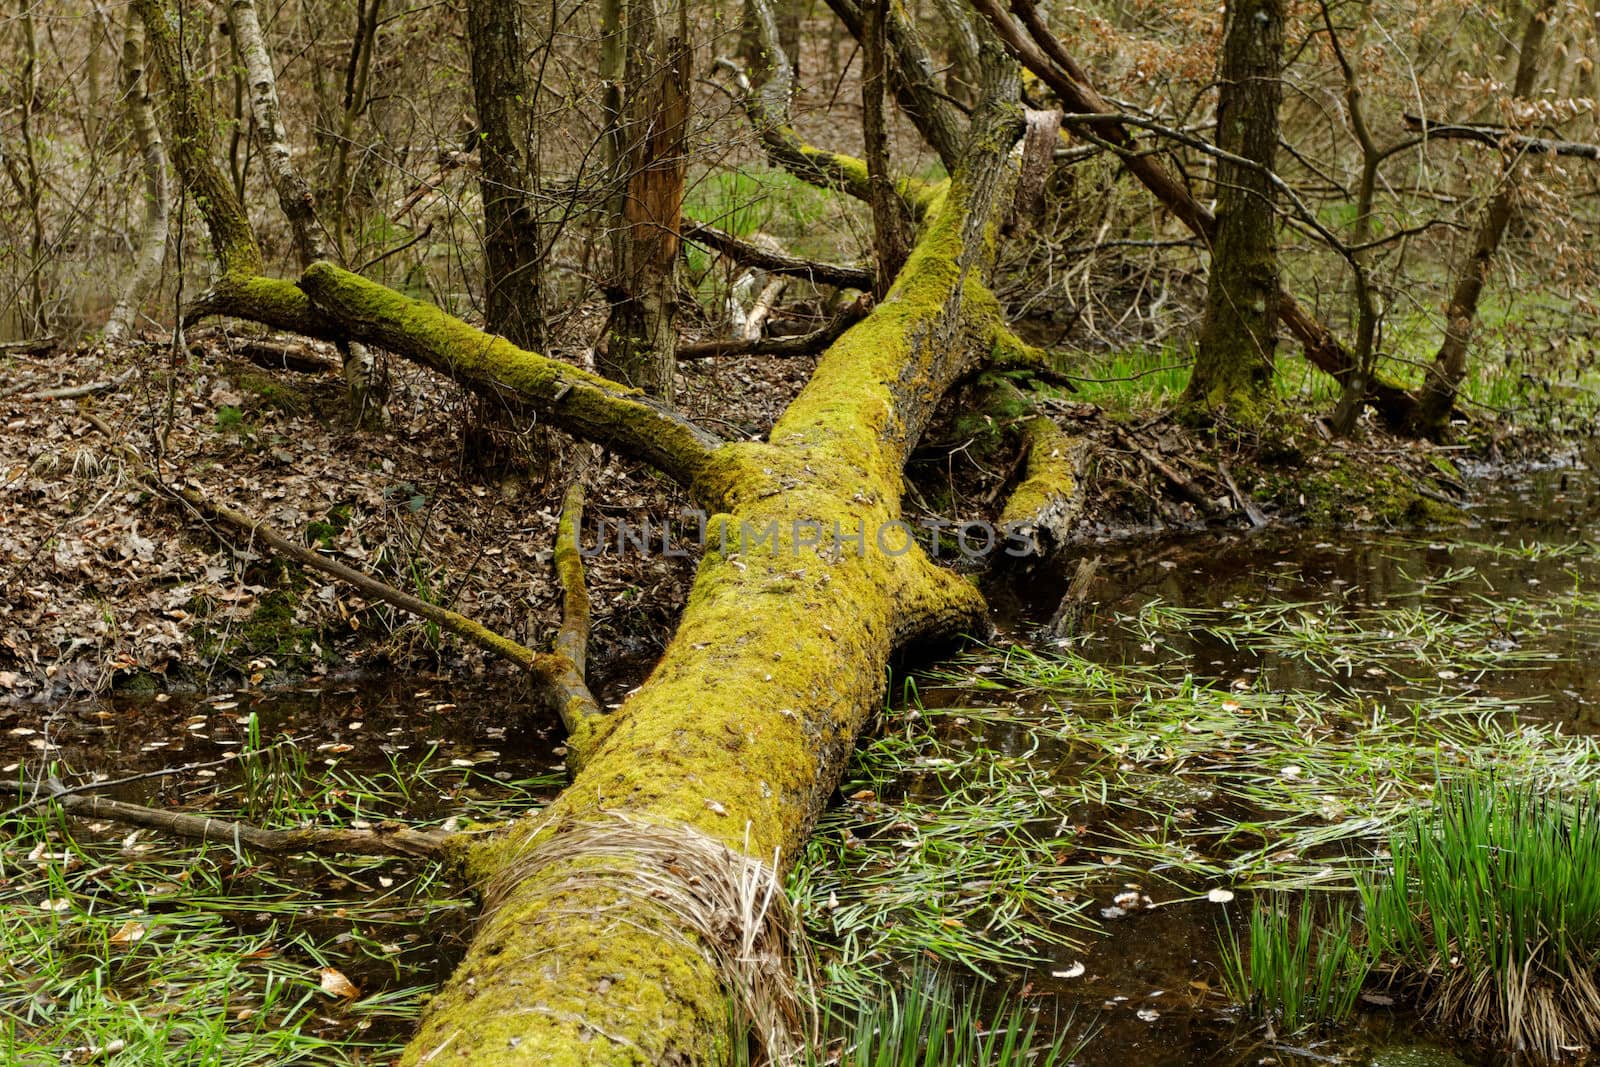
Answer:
[966,461,1600,1067]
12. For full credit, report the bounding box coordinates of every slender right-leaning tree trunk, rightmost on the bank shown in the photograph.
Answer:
[1411,0,1555,440]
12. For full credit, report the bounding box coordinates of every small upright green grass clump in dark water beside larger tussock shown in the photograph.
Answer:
[1221,897,1371,1035]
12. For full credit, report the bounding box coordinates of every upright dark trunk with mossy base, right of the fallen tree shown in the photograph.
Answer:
[1184,0,1285,421]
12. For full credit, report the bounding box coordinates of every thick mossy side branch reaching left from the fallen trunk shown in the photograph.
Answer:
[301,262,723,490]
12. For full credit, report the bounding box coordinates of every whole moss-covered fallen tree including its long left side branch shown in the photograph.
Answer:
[136,0,1022,1067]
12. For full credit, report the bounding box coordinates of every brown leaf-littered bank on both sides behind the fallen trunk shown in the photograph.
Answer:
[0,330,1548,701]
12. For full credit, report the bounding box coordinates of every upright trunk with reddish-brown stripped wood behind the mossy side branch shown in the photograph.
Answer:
[598,0,691,400]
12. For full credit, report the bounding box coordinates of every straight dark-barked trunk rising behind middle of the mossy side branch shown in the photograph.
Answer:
[467,0,544,349]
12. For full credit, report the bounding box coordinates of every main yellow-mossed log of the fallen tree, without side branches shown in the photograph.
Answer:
[393,77,1021,1067]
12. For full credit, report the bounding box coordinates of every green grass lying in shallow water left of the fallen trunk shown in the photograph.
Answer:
[0,742,557,1067]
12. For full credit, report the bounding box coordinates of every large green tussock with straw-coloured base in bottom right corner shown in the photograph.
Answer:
[1360,777,1600,1059]
